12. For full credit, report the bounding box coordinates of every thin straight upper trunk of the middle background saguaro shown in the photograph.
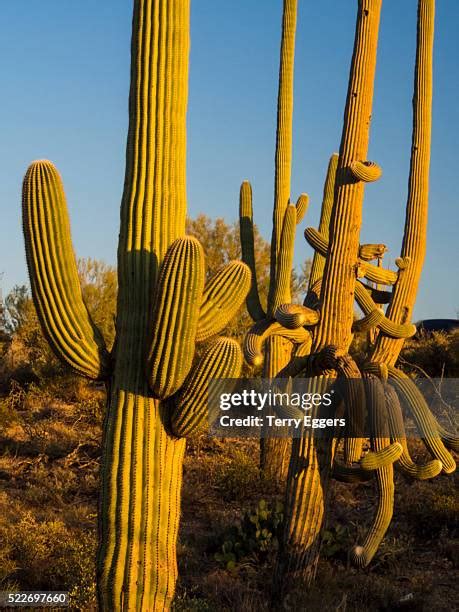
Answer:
[268,0,297,317]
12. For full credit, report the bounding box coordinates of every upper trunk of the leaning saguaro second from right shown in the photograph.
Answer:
[315,0,381,350]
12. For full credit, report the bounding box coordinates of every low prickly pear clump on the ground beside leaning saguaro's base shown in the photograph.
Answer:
[214,499,283,571]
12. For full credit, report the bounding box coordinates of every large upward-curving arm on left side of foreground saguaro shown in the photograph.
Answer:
[22,160,110,379]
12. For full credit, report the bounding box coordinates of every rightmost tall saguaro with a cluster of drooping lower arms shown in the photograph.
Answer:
[352,0,457,566]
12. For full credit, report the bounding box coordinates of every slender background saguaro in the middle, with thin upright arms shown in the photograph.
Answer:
[239,0,308,480]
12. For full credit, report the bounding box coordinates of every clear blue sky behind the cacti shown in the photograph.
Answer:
[0,0,459,318]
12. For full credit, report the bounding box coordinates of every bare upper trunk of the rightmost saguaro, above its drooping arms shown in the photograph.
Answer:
[372,0,435,365]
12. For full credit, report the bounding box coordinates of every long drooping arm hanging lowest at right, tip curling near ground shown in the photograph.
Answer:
[351,376,396,567]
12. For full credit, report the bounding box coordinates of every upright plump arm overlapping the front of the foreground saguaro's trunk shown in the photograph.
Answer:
[146,236,205,399]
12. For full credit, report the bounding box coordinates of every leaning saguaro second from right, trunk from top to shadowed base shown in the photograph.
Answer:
[276,0,381,591]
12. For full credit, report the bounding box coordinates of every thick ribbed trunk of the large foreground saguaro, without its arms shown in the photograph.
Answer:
[98,0,189,610]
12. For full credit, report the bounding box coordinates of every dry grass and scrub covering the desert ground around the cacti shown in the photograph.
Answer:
[0,386,458,612]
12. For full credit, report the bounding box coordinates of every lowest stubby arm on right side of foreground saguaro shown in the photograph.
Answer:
[170,338,242,438]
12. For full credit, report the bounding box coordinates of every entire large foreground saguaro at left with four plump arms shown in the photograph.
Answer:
[23,0,250,612]
